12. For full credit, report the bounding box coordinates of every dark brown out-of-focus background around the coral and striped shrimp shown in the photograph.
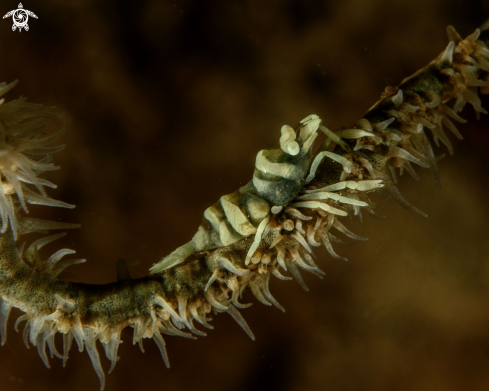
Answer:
[0,0,489,391]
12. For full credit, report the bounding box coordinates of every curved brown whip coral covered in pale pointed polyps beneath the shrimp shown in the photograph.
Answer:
[0,20,489,389]
